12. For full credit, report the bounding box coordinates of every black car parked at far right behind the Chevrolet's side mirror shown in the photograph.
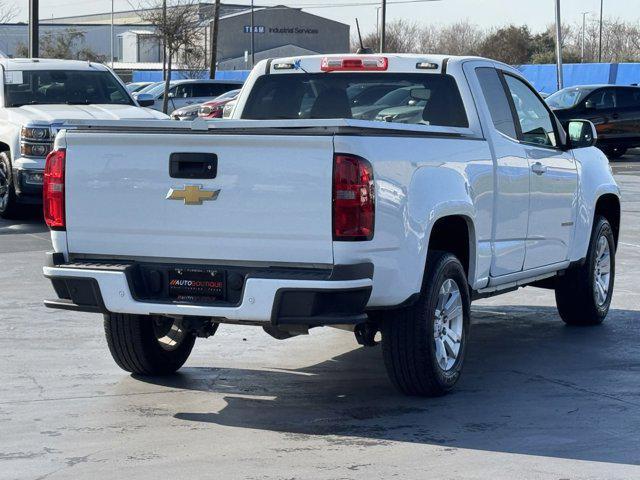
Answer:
[546,85,640,159]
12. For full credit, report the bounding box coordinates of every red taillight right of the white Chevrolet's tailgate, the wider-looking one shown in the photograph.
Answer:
[333,154,375,241]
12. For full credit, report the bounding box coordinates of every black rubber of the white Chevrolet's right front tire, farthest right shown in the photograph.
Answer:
[556,216,616,325]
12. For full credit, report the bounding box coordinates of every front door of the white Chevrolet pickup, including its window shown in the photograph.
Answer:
[502,72,578,270]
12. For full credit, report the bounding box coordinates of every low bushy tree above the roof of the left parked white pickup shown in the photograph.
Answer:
[16,28,106,63]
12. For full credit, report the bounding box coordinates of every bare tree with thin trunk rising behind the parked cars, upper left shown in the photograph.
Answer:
[138,0,202,113]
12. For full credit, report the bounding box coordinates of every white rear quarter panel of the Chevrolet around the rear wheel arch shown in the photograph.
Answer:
[334,136,493,307]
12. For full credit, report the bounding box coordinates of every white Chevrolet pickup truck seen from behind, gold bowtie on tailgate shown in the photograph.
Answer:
[44,54,620,395]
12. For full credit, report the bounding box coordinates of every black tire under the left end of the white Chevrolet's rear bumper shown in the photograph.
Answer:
[104,313,195,375]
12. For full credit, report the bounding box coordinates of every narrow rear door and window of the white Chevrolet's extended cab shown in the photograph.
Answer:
[465,62,529,277]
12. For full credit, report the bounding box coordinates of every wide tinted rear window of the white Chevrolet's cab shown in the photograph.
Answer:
[242,72,469,127]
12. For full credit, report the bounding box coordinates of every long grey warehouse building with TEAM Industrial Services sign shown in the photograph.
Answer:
[0,2,350,70]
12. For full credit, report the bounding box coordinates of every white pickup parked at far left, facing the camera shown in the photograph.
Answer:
[0,58,167,218]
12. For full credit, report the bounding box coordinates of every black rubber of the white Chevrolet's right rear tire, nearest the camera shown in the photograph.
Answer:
[381,251,471,397]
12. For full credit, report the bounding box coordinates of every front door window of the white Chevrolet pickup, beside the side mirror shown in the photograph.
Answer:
[504,75,558,147]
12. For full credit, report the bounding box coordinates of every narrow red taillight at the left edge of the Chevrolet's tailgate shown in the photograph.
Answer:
[42,149,67,230]
